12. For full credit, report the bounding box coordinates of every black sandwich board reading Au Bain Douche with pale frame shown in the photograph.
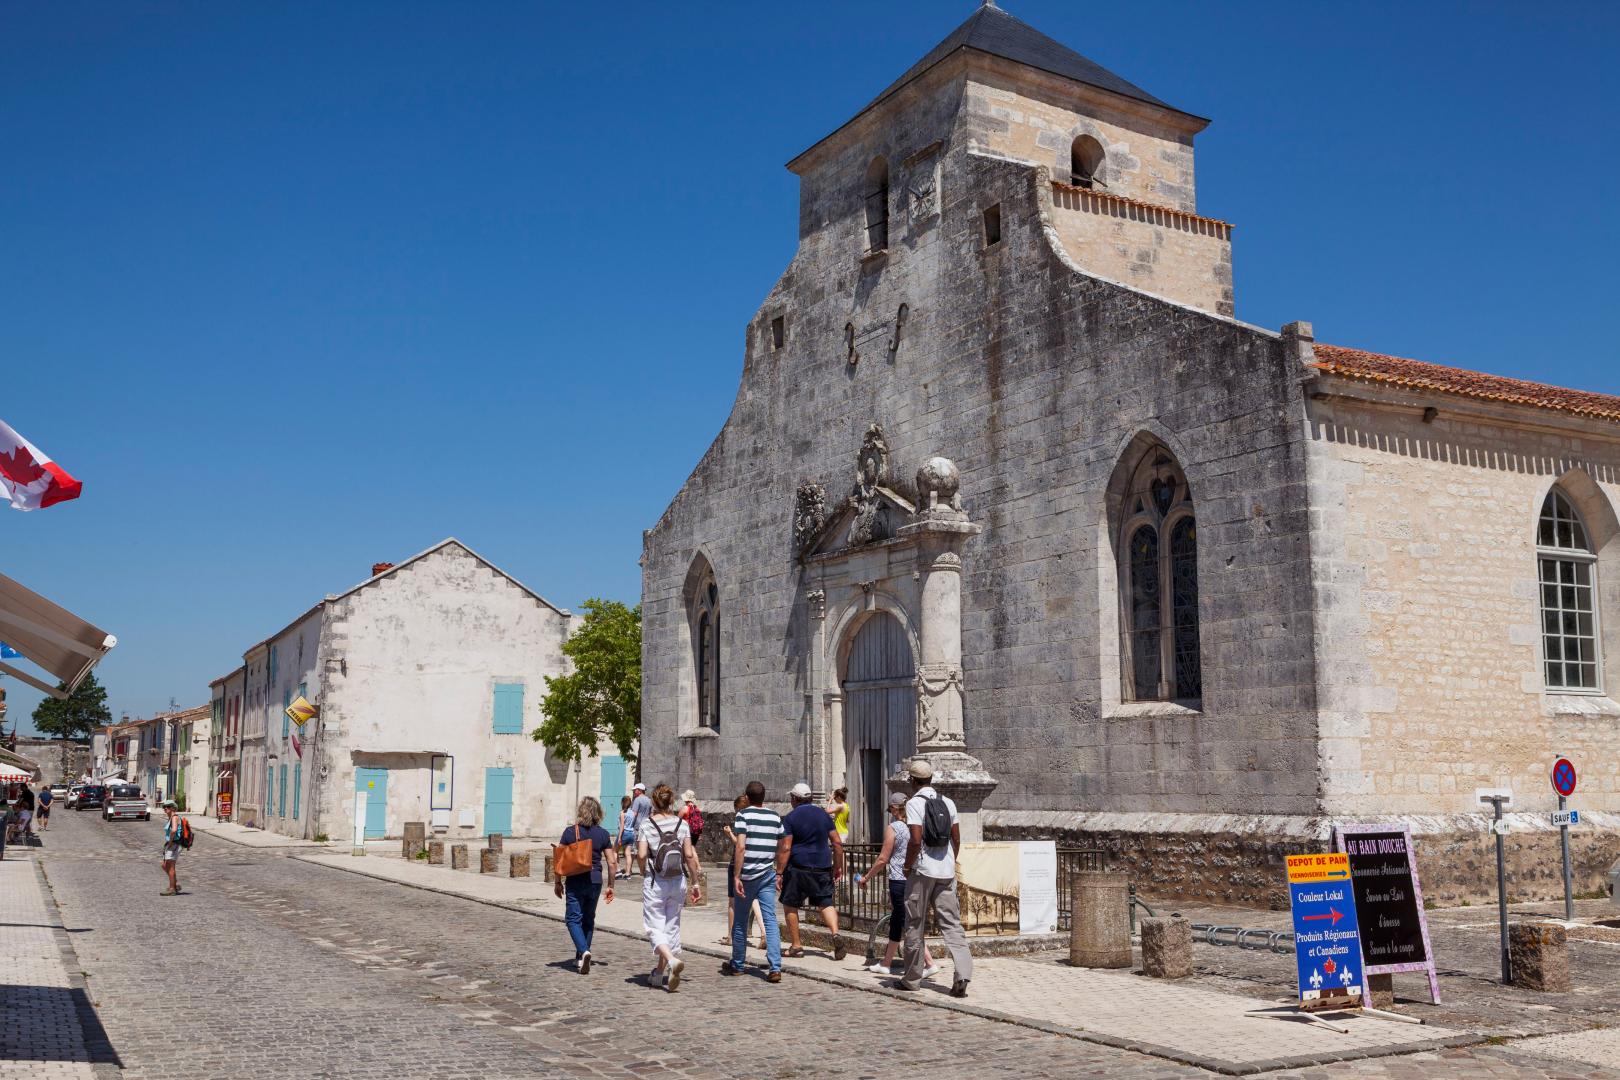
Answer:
[1333,824,1440,1006]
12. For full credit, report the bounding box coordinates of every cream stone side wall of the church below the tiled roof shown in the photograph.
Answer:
[1307,381,1620,814]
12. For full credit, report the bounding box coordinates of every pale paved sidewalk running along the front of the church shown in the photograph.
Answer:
[293,852,1481,1075]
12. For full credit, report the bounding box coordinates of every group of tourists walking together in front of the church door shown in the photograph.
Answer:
[554,758,972,997]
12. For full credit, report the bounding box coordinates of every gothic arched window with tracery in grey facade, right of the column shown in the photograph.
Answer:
[1118,447,1204,701]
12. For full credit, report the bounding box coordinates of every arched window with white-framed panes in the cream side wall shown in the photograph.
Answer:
[1536,487,1602,691]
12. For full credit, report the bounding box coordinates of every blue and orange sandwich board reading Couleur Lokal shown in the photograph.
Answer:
[1288,852,1362,1010]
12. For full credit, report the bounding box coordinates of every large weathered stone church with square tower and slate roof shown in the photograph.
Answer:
[642,3,1620,904]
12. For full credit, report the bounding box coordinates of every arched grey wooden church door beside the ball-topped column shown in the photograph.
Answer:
[844,610,917,844]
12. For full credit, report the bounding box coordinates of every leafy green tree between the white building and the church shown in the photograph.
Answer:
[531,599,642,761]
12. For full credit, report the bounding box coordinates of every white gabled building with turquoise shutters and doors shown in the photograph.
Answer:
[215,539,601,840]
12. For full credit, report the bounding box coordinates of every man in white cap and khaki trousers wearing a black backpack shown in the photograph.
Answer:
[897,758,974,997]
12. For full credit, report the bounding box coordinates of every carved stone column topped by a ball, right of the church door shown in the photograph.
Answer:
[889,457,996,844]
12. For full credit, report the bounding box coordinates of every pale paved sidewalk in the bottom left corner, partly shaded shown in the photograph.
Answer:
[0,844,107,1080]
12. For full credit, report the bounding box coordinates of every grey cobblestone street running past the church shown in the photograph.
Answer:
[3,814,1620,1080]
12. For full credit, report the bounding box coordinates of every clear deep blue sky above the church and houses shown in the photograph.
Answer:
[0,0,1620,729]
